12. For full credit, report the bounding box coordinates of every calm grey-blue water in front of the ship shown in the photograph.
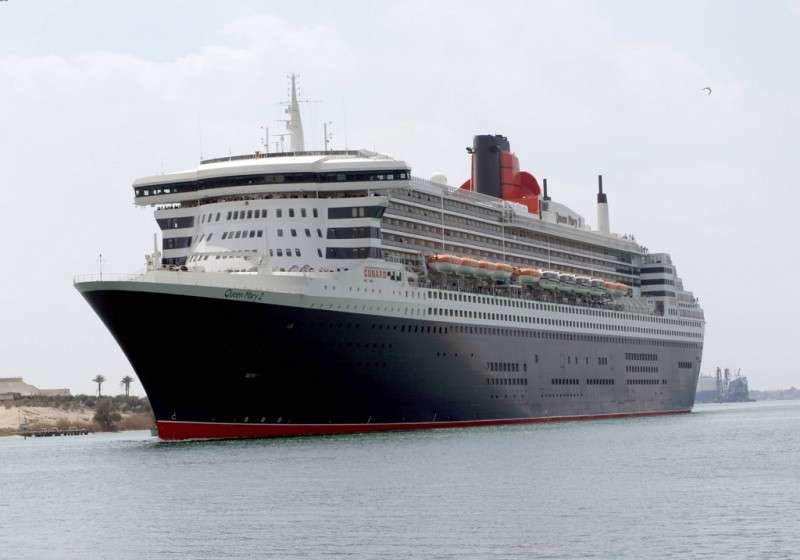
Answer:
[0,401,800,560]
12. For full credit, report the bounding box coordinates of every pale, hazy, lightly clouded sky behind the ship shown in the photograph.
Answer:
[0,0,800,394]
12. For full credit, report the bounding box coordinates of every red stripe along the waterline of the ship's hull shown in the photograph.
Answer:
[156,409,690,441]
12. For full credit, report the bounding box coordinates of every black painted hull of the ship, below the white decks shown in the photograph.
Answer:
[81,288,700,439]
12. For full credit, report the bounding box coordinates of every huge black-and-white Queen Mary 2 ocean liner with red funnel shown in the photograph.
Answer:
[75,76,705,440]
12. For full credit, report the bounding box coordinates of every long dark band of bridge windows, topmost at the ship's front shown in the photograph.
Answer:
[134,169,409,197]
